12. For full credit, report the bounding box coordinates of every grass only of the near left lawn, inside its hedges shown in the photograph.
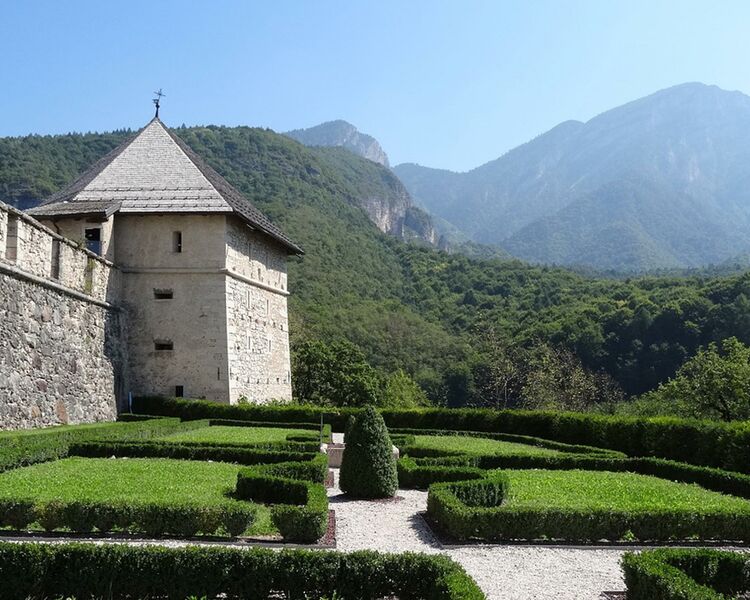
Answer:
[0,458,276,534]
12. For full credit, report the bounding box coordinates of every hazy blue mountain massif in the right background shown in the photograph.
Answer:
[394,83,750,271]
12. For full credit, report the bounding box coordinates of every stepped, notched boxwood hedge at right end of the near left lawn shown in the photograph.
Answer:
[236,454,328,543]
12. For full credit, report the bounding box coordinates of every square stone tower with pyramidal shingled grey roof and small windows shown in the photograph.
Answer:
[28,118,302,403]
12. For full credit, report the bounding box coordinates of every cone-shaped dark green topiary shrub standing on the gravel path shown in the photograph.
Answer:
[340,406,398,498]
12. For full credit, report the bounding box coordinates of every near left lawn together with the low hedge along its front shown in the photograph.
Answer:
[0,458,262,536]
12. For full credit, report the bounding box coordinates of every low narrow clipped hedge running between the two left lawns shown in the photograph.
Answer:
[69,441,320,465]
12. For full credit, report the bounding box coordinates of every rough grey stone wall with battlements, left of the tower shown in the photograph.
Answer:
[0,203,124,429]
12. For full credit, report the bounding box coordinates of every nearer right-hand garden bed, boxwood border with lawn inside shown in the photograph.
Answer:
[427,469,750,542]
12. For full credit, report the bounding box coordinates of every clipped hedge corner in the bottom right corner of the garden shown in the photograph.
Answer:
[622,549,750,600]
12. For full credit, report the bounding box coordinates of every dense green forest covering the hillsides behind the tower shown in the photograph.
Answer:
[0,127,750,405]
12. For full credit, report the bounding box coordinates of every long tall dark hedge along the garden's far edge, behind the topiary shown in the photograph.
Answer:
[133,398,750,473]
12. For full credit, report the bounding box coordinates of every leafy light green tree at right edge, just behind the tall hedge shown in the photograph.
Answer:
[639,337,750,421]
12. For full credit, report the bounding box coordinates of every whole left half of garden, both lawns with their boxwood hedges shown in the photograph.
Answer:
[0,416,330,543]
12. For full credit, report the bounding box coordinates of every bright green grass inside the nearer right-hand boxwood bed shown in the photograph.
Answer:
[503,470,750,512]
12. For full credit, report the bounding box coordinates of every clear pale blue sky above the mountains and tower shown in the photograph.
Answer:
[0,0,750,170]
